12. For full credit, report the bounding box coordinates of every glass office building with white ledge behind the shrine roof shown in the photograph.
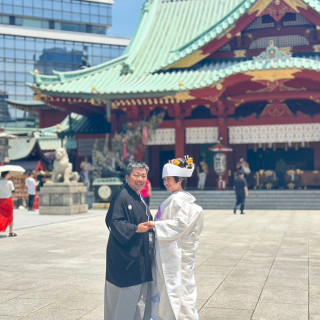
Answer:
[0,0,129,117]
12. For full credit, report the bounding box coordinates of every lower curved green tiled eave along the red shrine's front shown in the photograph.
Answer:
[30,56,320,97]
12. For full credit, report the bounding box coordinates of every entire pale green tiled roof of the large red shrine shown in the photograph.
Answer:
[29,0,320,99]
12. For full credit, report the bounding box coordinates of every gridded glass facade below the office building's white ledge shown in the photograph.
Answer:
[0,35,125,100]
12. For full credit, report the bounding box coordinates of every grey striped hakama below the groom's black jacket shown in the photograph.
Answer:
[104,281,151,320]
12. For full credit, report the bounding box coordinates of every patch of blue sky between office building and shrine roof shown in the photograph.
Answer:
[108,0,145,38]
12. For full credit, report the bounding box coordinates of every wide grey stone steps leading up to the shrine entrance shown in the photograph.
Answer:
[150,190,320,212]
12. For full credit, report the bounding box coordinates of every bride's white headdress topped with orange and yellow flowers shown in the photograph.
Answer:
[162,155,194,178]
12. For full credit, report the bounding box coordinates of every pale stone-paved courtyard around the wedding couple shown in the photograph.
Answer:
[0,210,320,320]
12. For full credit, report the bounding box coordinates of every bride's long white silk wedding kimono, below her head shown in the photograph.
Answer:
[152,192,204,320]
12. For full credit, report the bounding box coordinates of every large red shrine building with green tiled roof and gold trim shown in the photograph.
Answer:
[29,0,320,188]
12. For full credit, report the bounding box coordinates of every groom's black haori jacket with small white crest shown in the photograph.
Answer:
[106,184,152,288]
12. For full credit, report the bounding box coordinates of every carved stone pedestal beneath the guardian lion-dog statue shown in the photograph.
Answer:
[39,182,88,215]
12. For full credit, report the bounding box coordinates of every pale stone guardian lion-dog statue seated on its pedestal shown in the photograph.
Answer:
[51,148,79,183]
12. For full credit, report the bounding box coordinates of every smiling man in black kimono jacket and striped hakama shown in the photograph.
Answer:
[104,161,152,320]
